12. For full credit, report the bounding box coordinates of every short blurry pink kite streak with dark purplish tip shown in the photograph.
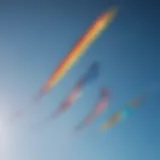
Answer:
[73,88,110,133]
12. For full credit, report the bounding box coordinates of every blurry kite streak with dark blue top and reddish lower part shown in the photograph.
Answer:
[34,61,100,127]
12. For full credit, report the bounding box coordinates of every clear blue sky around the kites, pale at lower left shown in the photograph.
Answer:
[0,0,160,160]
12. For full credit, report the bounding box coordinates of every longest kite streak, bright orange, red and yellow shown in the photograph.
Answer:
[36,7,117,101]
